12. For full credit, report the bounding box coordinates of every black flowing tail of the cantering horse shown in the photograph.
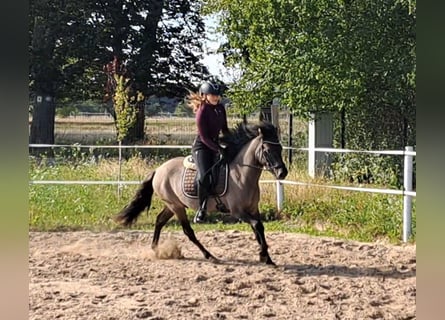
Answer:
[114,171,156,226]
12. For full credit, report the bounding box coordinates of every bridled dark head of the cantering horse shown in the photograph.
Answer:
[255,123,288,180]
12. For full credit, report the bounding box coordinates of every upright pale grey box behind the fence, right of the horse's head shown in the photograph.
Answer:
[308,112,334,178]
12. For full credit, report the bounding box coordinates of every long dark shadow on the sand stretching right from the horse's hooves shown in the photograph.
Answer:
[176,257,416,279]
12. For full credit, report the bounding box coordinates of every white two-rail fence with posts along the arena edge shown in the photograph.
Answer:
[29,144,417,242]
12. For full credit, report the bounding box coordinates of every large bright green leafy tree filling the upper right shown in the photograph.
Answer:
[206,0,416,148]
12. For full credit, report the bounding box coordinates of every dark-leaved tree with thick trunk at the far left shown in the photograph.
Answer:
[29,0,109,144]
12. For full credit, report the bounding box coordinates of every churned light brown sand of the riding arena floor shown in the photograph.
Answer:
[29,230,416,320]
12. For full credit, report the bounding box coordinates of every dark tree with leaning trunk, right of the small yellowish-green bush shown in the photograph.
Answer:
[97,0,208,142]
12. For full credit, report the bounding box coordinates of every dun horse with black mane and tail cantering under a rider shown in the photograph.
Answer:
[114,121,288,265]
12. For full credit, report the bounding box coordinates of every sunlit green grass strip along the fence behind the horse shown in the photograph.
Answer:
[29,154,416,243]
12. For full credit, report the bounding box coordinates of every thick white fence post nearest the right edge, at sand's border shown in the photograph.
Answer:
[403,147,413,242]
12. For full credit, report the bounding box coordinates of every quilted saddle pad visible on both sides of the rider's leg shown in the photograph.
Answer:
[181,155,229,198]
